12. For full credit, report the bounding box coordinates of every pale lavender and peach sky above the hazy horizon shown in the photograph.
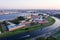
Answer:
[0,0,60,9]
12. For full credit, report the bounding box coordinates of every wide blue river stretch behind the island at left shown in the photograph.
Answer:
[0,13,29,20]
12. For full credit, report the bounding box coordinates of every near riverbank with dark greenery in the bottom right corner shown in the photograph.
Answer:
[27,26,60,40]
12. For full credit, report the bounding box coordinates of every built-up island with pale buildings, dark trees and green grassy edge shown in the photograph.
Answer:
[0,13,55,37]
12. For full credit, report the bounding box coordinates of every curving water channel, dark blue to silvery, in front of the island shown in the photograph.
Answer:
[0,17,60,40]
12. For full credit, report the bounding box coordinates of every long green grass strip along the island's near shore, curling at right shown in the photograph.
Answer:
[0,17,55,37]
